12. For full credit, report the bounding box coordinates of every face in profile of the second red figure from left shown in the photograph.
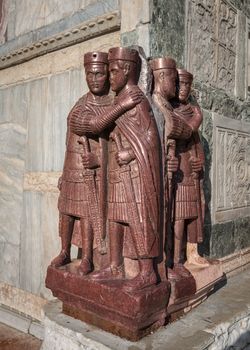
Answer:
[109,61,130,93]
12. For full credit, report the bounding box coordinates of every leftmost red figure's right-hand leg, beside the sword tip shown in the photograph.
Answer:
[78,218,93,275]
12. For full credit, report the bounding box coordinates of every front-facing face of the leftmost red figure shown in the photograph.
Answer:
[85,63,109,95]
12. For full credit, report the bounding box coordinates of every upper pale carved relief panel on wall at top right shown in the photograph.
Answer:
[188,0,237,93]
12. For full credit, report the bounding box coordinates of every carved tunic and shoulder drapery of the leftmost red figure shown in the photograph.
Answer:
[58,93,111,218]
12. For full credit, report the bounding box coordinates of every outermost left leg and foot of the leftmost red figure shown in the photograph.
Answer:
[51,214,75,267]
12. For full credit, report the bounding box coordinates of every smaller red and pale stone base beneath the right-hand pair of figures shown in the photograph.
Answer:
[167,262,225,321]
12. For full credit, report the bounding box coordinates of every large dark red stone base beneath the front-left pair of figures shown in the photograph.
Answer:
[46,262,169,341]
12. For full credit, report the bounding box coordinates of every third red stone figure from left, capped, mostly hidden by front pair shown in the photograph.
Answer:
[151,57,192,277]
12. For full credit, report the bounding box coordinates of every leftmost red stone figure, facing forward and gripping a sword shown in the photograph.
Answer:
[51,52,112,274]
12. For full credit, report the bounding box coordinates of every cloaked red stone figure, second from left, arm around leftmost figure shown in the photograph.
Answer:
[71,48,159,291]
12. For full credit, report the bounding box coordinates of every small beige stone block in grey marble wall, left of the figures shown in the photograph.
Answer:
[23,172,62,193]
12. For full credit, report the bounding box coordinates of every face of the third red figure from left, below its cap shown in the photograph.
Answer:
[159,69,177,100]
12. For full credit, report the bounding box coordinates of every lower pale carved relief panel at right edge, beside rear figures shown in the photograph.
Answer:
[215,127,250,211]
